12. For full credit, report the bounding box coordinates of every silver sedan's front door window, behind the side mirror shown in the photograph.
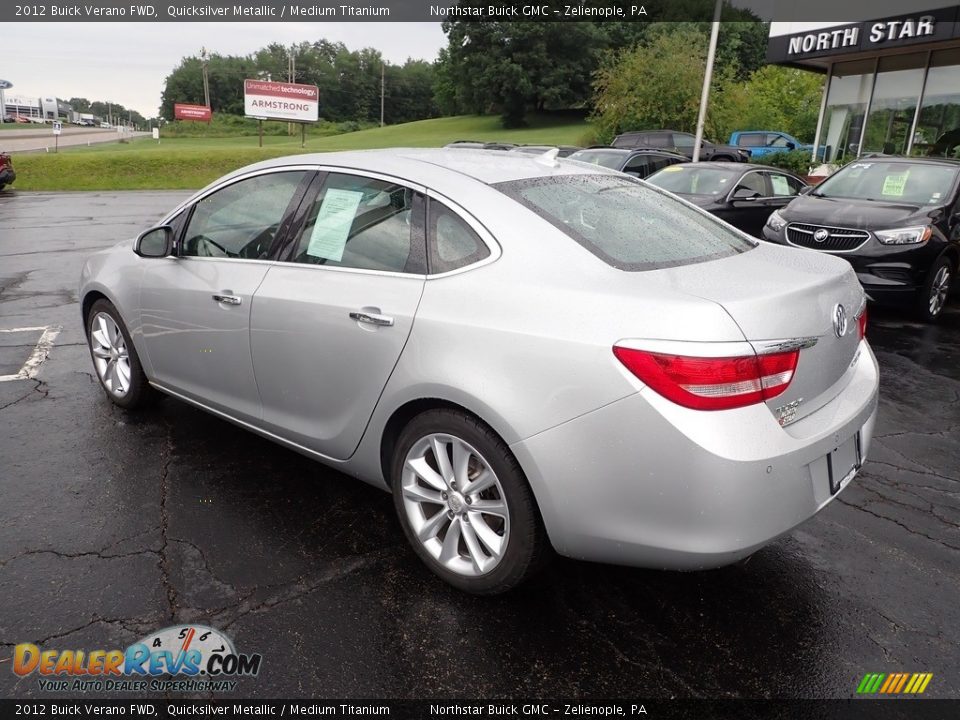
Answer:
[180,171,305,260]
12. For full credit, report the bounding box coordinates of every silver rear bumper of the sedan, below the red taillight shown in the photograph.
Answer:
[512,342,878,570]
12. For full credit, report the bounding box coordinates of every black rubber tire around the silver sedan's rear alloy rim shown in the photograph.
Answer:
[390,409,549,595]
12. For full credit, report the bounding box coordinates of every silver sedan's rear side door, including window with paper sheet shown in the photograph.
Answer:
[250,172,426,459]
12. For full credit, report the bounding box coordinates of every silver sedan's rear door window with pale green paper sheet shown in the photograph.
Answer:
[292,173,426,274]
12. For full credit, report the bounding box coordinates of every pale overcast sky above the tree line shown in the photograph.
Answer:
[0,22,446,117]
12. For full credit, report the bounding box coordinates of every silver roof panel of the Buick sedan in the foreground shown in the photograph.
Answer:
[209,148,615,187]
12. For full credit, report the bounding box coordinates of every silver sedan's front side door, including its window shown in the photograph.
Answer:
[140,169,312,421]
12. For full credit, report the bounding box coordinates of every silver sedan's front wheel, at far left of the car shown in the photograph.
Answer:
[87,300,154,408]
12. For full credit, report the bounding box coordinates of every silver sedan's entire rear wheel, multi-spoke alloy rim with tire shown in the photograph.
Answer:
[392,410,546,595]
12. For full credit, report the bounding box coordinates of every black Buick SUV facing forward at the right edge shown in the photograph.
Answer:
[763,157,960,322]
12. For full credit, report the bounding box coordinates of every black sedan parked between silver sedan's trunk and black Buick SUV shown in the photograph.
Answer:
[647,162,807,237]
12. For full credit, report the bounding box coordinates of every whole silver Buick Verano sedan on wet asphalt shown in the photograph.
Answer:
[80,149,878,594]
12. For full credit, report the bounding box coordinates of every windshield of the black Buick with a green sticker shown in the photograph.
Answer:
[811,160,957,205]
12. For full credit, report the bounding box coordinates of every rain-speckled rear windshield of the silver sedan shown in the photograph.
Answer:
[494,175,755,271]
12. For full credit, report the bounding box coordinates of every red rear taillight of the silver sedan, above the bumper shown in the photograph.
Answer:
[613,345,800,410]
